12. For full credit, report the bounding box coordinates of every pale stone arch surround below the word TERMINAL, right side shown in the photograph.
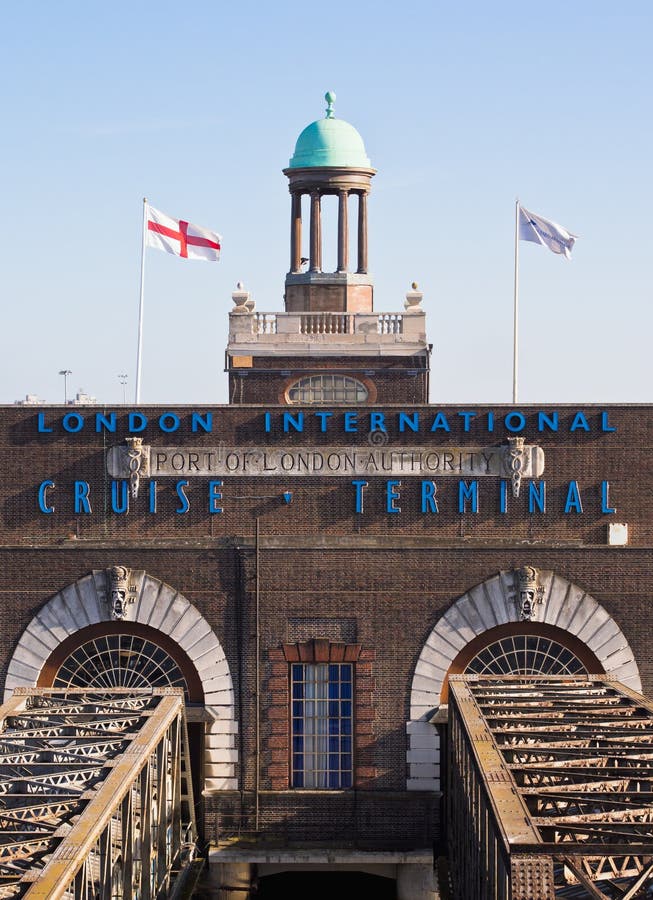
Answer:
[406,570,642,791]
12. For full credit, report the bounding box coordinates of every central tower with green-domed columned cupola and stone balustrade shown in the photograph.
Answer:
[227,91,430,406]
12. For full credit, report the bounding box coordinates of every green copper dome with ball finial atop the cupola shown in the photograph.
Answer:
[289,91,371,169]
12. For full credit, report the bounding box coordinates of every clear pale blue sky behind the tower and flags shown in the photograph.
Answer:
[0,0,653,404]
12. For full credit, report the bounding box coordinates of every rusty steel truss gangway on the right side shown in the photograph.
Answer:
[448,675,653,900]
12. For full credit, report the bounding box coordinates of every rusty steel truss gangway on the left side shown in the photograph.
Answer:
[0,688,198,900]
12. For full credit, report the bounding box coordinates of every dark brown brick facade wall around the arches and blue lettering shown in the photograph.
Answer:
[0,402,653,849]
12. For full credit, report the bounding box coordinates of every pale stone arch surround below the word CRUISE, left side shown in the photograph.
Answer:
[4,569,238,792]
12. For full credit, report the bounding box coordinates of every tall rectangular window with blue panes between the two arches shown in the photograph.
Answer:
[291,663,353,790]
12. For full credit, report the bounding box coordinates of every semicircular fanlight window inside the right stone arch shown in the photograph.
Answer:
[465,634,587,675]
